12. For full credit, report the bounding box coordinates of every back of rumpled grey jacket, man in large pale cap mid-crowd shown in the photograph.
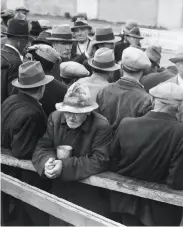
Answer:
[97,78,151,130]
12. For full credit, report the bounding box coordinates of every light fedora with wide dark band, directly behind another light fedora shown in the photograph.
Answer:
[88,27,121,44]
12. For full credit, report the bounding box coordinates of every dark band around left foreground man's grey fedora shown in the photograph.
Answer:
[18,71,45,85]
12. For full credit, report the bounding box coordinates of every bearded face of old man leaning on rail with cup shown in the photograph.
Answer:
[64,112,88,128]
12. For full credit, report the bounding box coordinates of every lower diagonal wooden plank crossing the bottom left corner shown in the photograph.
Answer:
[1,173,124,227]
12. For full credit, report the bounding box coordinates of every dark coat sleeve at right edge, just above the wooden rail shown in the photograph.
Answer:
[167,139,183,190]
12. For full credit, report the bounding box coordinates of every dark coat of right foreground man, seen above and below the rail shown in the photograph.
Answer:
[110,111,183,226]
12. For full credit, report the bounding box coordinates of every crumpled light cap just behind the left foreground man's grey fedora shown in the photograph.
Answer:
[28,44,61,63]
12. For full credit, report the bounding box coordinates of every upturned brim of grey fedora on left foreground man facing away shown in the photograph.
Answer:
[12,75,54,88]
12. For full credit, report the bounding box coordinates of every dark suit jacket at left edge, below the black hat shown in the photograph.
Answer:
[1,46,22,101]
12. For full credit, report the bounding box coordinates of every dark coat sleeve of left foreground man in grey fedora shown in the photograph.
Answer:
[11,114,45,159]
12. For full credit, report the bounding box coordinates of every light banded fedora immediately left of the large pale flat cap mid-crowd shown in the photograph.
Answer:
[88,47,120,72]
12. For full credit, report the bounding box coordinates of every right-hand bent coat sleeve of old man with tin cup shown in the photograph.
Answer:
[60,121,112,181]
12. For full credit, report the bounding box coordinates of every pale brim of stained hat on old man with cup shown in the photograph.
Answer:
[55,101,98,113]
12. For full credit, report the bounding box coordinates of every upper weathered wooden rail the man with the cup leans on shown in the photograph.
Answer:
[1,154,183,207]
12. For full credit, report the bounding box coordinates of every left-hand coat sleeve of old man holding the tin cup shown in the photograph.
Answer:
[32,114,56,176]
